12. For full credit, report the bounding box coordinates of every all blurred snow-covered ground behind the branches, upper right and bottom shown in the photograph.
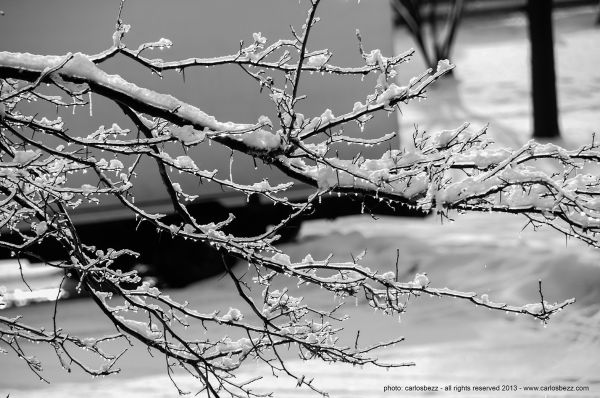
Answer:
[0,3,600,398]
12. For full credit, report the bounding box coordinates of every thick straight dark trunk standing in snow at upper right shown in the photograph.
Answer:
[527,0,560,138]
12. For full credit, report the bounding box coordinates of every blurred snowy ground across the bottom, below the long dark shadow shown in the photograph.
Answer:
[0,215,600,398]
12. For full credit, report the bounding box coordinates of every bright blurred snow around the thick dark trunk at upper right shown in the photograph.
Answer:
[395,7,600,148]
